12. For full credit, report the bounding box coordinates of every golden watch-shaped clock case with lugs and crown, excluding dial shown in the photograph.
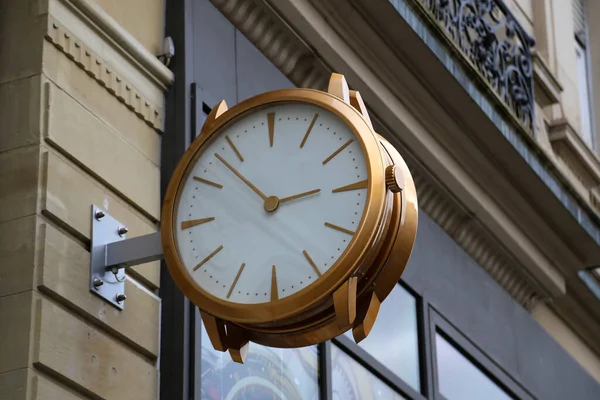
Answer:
[161,73,418,362]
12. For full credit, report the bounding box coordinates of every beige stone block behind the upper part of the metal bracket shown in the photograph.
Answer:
[41,151,160,288]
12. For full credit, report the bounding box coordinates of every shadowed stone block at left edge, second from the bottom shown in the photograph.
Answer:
[0,291,33,374]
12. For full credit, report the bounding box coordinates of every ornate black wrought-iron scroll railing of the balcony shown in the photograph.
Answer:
[416,0,535,132]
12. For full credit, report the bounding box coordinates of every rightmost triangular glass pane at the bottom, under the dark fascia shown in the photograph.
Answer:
[435,334,512,400]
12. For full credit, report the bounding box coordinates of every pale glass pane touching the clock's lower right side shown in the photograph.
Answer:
[346,285,421,392]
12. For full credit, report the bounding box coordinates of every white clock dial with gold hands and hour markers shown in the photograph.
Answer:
[173,102,369,304]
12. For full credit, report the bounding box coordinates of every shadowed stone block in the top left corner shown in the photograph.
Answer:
[0,0,46,83]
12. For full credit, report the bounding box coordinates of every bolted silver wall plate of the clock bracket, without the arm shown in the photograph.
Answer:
[90,205,126,310]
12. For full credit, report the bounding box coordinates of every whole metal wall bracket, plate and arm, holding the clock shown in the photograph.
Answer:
[90,205,163,310]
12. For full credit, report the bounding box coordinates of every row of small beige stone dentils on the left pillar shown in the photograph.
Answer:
[46,17,164,132]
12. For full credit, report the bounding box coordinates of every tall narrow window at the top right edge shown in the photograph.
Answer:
[573,0,595,148]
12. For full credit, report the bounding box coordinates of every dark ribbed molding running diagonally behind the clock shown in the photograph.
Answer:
[211,0,549,310]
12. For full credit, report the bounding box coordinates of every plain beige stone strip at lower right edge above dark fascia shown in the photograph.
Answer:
[532,304,600,383]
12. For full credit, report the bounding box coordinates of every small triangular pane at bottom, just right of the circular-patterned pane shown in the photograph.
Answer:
[331,346,405,400]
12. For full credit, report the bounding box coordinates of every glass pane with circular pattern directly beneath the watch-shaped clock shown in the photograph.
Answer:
[197,329,319,400]
